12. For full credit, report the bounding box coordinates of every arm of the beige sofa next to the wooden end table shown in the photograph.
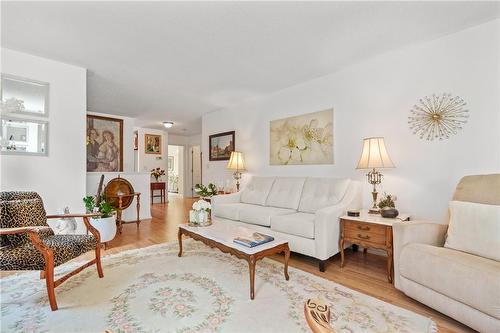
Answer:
[392,221,448,289]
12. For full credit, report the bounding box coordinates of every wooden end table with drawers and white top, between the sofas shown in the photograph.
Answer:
[339,210,410,283]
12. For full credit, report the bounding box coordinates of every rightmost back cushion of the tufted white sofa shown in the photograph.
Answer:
[299,178,351,213]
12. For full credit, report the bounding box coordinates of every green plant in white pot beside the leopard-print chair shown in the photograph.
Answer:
[83,195,116,244]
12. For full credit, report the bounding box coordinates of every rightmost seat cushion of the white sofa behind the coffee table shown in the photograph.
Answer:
[271,213,315,239]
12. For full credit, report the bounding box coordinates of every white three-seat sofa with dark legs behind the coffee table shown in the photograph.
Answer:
[212,176,362,271]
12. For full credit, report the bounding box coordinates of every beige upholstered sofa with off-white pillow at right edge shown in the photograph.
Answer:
[393,174,500,333]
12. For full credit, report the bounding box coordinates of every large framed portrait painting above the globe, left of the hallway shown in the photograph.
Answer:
[87,115,123,172]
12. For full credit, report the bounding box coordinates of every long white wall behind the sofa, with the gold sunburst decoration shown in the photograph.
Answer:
[202,20,500,222]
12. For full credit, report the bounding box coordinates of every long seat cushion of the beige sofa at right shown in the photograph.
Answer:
[399,243,500,319]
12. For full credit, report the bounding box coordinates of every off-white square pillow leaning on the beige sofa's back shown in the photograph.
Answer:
[444,201,500,261]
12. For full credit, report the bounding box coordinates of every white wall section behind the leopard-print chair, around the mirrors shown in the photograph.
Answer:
[0,48,87,213]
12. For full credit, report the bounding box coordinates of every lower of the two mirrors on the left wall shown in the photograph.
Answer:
[0,118,48,155]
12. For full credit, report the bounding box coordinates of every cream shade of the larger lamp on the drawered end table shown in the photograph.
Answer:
[356,138,395,169]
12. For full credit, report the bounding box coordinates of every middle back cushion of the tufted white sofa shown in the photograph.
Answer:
[266,177,306,209]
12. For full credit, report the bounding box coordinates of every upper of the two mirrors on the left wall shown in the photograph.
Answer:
[1,74,49,116]
